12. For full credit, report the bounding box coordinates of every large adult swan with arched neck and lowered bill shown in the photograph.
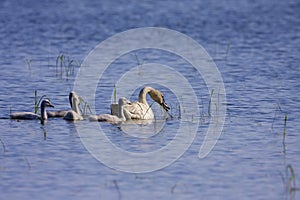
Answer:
[124,86,170,120]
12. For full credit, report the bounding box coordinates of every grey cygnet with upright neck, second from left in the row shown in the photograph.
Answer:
[64,92,83,121]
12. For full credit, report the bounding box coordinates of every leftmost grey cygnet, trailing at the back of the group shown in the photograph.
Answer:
[10,99,54,121]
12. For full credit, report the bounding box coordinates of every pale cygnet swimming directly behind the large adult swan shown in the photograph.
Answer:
[89,97,130,124]
